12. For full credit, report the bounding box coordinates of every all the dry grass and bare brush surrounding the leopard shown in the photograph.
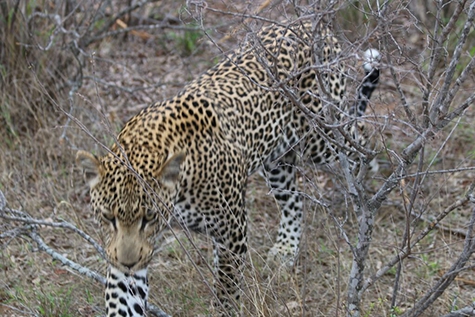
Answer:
[0,0,475,316]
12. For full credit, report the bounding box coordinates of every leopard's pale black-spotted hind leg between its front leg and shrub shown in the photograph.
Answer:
[262,151,303,266]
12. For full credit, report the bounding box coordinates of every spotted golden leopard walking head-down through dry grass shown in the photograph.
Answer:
[77,21,380,316]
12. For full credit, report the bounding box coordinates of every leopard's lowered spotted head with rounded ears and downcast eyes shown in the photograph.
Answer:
[77,151,185,273]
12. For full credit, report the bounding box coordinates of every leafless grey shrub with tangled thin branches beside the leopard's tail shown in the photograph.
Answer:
[332,1,475,316]
